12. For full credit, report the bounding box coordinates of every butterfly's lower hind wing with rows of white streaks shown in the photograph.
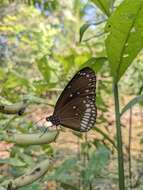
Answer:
[60,96,97,132]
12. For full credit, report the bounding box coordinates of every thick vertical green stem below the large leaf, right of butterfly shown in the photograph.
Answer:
[114,83,125,190]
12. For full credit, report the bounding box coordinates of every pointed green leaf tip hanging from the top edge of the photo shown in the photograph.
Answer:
[91,0,114,16]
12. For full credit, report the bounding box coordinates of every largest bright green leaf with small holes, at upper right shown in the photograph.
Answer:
[105,0,143,82]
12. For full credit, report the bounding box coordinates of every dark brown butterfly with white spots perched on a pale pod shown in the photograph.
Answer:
[46,67,97,132]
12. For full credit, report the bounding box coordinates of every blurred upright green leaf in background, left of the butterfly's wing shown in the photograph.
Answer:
[37,56,51,82]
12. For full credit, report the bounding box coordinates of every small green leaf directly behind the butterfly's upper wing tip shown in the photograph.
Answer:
[81,57,107,72]
